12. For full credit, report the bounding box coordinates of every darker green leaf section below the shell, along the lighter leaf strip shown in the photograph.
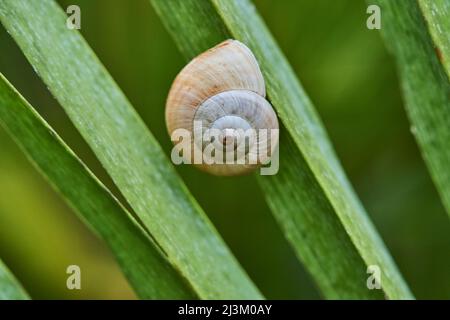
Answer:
[258,128,383,299]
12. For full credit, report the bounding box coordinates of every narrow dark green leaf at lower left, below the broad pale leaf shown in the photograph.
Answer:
[0,74,195,299]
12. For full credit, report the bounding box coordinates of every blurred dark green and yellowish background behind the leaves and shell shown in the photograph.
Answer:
[0,0,450,299]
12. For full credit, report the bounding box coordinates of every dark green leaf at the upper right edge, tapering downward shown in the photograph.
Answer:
[377,0,450,215]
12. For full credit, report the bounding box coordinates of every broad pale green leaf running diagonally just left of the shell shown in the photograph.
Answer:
[0,0,262,299]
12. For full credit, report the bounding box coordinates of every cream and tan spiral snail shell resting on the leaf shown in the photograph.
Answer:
[165,40,278,176]
